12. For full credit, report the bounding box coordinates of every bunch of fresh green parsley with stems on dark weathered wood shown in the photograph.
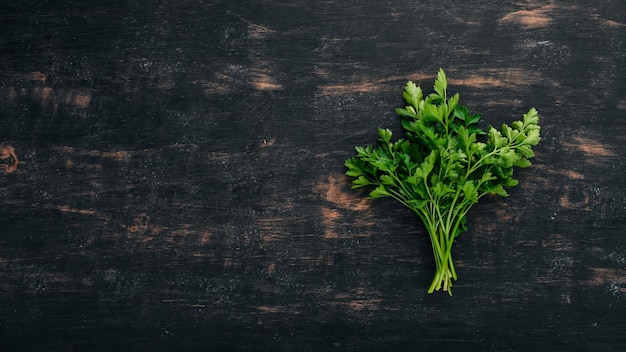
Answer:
[345,69,541,295]
